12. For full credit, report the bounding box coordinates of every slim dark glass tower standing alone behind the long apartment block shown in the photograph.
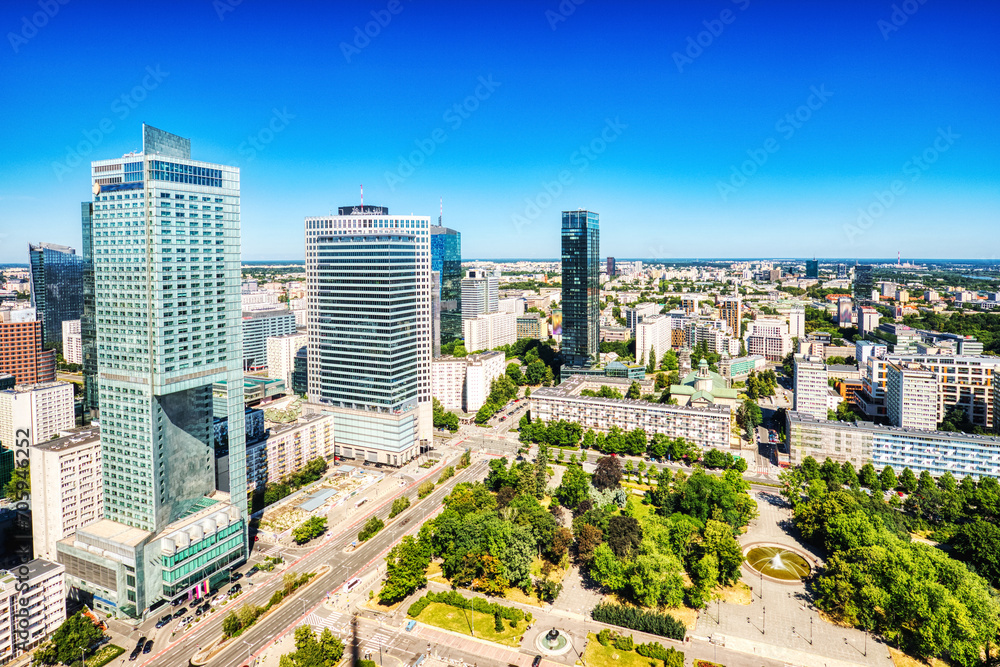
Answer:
[562,209,601,366]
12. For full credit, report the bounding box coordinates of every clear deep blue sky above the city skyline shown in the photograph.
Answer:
[0,0,1000,263]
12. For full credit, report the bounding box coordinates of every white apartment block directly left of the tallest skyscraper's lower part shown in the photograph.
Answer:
[28,426,104,561]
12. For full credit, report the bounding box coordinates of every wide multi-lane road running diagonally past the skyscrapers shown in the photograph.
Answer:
[143,461,488,667]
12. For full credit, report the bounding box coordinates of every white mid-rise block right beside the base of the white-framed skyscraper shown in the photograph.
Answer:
[431,351,507,412]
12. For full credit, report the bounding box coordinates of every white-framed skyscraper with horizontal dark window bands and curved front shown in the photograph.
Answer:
[305,206,433,465]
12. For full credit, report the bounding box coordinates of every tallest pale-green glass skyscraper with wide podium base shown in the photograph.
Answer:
[57,125,247,617]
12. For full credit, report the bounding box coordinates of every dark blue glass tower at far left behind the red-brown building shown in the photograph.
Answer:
[28,243,84,345]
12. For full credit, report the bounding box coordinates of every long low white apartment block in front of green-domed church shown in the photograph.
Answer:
[531,375,733,449]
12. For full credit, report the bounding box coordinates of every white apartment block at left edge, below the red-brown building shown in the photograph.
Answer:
[0,382,76,448]
